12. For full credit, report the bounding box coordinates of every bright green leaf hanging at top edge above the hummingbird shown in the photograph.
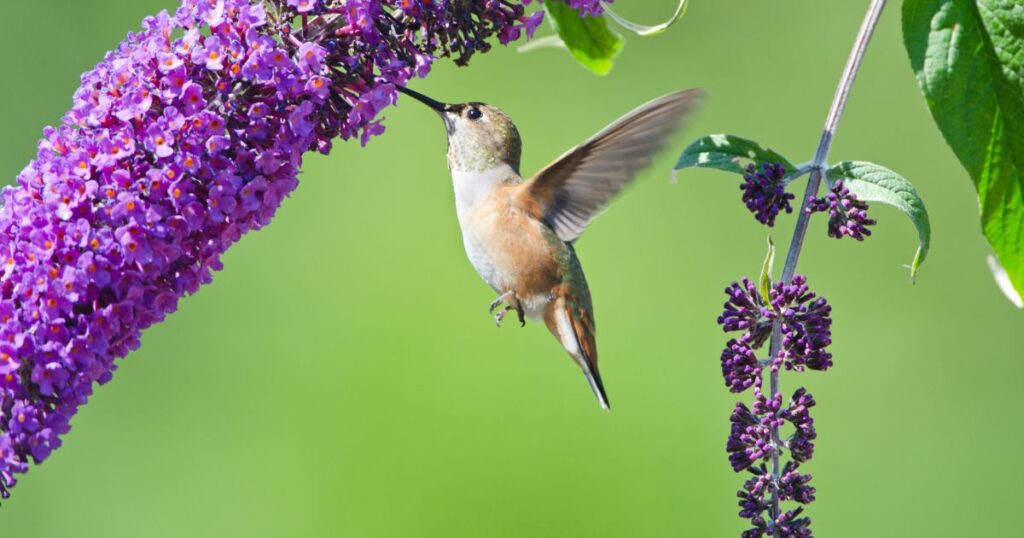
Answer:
[544,0,626,75]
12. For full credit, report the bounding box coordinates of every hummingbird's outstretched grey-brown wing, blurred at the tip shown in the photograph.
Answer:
[522,89,703,243]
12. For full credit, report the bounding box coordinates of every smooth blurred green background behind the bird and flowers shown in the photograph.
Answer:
[0,0,1024,538]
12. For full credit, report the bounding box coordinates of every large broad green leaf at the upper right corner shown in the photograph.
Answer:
[903,0,1024,299]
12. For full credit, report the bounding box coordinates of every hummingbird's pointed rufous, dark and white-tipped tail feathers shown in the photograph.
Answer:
[544,290,611,410]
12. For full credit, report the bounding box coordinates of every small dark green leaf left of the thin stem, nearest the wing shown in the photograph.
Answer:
[676,134,796,174]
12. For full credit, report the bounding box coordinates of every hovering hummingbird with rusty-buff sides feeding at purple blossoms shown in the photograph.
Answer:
[397,86,703,410]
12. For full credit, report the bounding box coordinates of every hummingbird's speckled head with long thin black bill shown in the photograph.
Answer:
[398,86,522,174]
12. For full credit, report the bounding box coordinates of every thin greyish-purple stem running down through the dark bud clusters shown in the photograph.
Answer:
[768,0,887,538]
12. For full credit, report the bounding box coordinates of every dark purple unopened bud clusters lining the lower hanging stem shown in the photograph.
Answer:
[718,275,831,537]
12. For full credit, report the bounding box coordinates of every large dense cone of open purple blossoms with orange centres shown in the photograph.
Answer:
[0,0,577,497]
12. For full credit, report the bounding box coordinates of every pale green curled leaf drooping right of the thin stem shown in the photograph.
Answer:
[826,161,932,279]
